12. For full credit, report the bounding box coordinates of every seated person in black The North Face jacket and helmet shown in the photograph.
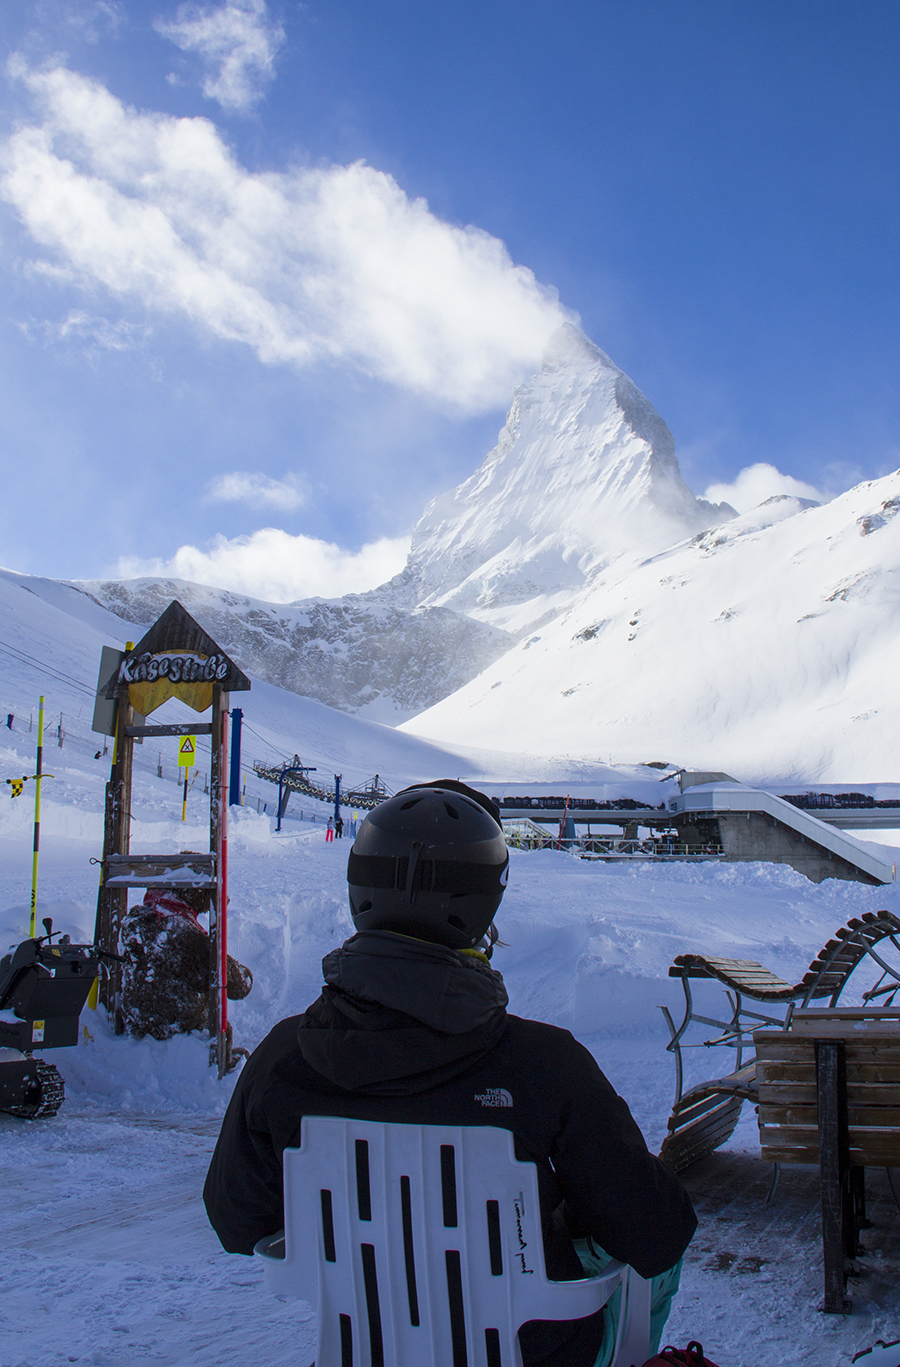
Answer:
[204,781,696,1367]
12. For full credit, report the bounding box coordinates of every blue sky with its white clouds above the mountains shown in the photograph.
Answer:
[0,0,900,597]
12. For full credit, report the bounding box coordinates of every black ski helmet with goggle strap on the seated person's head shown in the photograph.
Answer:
[347,779,509,949]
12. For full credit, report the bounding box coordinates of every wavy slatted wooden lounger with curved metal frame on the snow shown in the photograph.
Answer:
[659,910,900,1172]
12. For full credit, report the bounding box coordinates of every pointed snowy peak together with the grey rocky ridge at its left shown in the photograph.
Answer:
[78,324,734,722]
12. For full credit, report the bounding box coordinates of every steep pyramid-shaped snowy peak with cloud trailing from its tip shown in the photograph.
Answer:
[409,323,734,630]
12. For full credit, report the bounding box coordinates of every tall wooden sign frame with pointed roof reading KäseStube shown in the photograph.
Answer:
[94,601,250,1077]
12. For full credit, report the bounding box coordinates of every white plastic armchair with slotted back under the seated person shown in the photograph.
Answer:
[254,1115,650,1367]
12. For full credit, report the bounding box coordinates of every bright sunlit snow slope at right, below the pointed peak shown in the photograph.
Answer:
[405,472,900,782]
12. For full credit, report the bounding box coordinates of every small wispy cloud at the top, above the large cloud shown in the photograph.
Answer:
[153,0,284,112]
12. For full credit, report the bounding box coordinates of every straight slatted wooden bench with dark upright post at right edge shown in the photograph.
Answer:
[754,1009,900,1314]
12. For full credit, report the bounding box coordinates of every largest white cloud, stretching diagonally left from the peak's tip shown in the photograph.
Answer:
[0,60,568,413]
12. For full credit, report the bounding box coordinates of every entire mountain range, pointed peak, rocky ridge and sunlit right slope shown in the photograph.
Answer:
[45,315,900,782]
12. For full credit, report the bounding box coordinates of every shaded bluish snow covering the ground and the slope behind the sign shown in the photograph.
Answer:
[0,580,900,1367]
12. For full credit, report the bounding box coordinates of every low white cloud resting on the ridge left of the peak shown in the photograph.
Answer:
[114,526,409,603]
